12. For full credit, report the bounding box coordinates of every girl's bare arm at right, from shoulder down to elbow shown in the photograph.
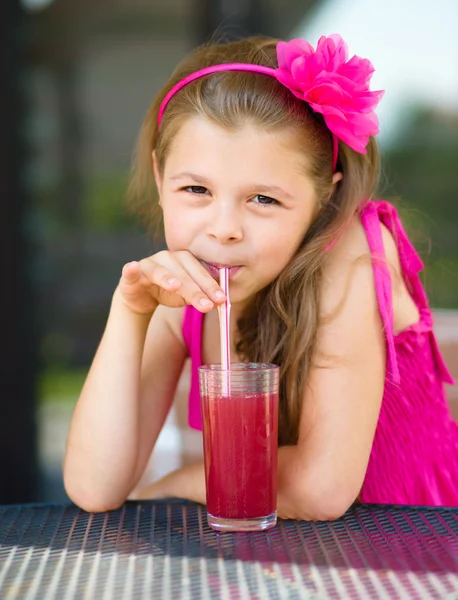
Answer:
[279,223,392,519]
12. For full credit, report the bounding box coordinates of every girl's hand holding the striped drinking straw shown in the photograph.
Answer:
[118,250,226,315]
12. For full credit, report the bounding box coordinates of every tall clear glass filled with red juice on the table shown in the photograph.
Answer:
[199,363,280,531]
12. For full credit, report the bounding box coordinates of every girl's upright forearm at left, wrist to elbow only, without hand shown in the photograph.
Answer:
[64,292,151,511]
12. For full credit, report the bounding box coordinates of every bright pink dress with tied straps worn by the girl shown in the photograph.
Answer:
[183,201,458,506]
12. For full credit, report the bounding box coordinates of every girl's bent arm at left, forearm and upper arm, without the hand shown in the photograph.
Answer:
[64,293,186,512]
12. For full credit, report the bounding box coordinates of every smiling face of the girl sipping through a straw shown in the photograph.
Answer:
[155,117,316,306]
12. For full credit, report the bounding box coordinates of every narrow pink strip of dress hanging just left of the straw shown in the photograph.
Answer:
[183,306,204,429]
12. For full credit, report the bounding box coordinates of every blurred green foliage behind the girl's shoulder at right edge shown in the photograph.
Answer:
[382,108,458,309]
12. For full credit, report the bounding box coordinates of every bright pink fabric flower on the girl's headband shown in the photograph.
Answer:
[275,34,384,154]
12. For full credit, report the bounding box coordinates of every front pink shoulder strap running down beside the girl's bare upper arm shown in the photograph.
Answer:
[361,202,400,385]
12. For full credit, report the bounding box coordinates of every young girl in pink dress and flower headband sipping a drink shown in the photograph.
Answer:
[64,35,458,519]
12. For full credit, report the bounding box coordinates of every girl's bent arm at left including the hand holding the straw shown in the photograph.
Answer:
[64,251,224,512]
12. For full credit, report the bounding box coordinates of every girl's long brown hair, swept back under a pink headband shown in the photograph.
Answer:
[129,37,379,445]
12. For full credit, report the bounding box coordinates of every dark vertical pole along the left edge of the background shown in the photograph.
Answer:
[0,0,38,504]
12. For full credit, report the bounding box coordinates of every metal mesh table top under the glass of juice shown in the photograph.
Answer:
[0,501,458,600]
